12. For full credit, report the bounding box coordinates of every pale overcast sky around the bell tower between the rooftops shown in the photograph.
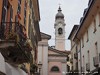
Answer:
[39,0,89,50]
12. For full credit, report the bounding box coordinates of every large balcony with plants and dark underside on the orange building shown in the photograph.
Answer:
[0,22,32,64]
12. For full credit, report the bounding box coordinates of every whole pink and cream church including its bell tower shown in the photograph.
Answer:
[38,7,70,75]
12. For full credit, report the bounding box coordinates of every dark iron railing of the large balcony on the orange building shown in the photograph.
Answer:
[0,22,26,42]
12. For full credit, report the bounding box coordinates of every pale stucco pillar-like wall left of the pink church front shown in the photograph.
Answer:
[38,39,48,75]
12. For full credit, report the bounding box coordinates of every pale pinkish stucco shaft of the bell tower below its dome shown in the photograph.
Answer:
[54,19,65,50]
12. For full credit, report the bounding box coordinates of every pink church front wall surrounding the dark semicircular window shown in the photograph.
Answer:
[48,55,67,75]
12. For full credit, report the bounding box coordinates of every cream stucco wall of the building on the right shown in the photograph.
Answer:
[79,9,100,71]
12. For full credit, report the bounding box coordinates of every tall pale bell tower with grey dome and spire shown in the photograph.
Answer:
[54,6,66,51]
